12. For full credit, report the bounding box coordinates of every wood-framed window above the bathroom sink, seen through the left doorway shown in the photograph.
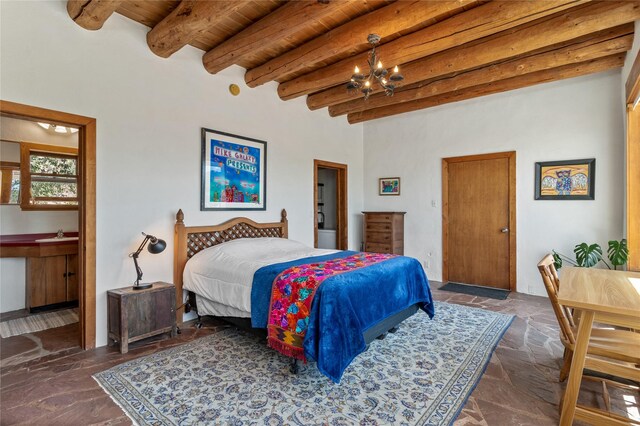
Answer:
[20,143,78,210]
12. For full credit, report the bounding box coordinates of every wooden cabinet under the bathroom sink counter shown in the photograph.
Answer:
[26,254,78,310]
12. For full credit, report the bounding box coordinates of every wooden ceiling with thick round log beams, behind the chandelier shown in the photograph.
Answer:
[67,0,640,123]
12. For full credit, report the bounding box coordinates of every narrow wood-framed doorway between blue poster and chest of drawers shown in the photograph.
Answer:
[313,160,349,250]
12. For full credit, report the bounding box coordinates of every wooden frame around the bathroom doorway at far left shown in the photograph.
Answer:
[0,100,96,349]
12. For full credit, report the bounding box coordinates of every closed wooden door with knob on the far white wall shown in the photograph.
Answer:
[443,152,515,290]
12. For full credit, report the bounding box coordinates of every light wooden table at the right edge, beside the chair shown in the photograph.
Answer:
[558,267,640,426]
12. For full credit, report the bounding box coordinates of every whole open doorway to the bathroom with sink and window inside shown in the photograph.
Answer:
[0,100,96,366]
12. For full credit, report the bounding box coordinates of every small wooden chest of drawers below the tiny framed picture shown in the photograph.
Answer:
[362,212,405,254]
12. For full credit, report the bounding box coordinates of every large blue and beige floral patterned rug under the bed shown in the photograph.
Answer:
[94,302,513,425]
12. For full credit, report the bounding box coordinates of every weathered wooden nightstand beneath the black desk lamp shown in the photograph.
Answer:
[107,282,177,354]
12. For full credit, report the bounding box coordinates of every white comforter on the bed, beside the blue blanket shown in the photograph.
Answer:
[183,238,337,317]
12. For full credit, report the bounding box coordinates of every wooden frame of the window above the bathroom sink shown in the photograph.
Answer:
[20,142,80,210]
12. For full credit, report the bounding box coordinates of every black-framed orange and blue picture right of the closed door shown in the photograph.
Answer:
[534,158,596,200]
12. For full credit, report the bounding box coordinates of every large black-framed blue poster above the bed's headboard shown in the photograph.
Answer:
[200,128,267,210]
